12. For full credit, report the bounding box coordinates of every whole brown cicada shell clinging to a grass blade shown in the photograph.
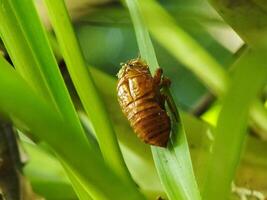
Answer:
[117,58,171,147]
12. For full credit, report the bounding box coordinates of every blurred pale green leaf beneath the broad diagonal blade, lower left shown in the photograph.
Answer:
[22,141,77,199]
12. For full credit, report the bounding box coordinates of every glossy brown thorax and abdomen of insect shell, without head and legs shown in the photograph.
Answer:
[117,75,170,147]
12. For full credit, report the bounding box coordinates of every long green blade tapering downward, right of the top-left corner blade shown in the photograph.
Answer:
[6,0,88,145]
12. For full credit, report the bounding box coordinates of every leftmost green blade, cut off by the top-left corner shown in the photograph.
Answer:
[0,0,51,97]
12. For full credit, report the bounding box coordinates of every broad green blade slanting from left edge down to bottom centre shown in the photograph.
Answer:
[0,57,147,200]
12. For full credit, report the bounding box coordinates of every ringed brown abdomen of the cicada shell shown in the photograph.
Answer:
[118,80,170,147]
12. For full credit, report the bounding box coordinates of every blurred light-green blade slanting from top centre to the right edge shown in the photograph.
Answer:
[137,0,267,137]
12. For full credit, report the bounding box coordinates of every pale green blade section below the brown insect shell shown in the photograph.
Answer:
[152,120,201,200]
